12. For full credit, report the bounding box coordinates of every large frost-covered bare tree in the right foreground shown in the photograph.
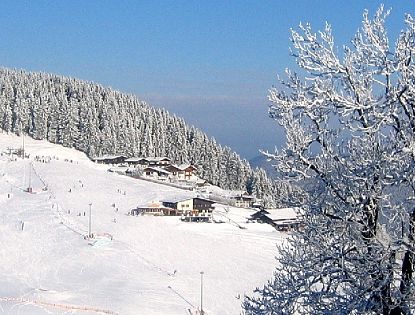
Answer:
[243,6,415,315]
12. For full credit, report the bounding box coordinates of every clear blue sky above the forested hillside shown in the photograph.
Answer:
[0,0,415,159]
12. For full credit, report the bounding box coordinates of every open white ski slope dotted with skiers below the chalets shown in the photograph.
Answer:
[0,133,283,315]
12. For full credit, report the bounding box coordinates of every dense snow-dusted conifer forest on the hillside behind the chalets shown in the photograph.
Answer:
[0,68,281,204]
